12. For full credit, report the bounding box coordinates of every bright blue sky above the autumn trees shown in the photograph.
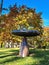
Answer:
[0,0,49,27]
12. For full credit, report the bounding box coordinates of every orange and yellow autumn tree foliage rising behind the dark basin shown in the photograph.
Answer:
[0,5,43,46]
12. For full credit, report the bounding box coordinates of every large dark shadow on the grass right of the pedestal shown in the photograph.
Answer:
[30,49,49,65]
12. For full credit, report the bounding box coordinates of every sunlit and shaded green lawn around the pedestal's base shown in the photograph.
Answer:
[0,48,49,65]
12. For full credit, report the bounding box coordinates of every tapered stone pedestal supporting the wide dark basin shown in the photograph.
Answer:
[19,37,29,57]
